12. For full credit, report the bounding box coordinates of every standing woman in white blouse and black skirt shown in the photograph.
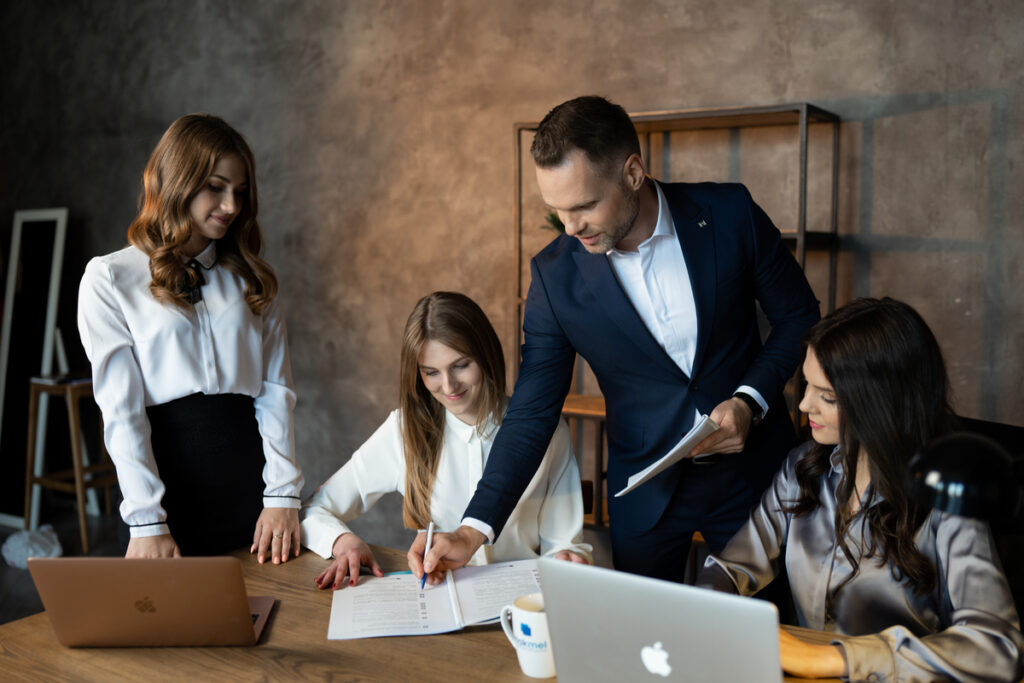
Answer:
[78,114,302,563]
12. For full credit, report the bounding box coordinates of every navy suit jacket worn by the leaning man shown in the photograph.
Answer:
[466,183,819,536]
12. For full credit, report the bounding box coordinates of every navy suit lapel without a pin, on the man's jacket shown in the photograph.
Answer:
[572,248,685,377]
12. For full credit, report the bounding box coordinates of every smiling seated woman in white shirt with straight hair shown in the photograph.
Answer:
[302,292,592,589]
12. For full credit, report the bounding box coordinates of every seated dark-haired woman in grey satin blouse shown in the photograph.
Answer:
[697,298,1024,682]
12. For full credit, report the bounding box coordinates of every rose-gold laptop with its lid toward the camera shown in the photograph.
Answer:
[28,557,274,647]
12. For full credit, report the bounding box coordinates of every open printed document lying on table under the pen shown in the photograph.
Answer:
[327,560,541,640]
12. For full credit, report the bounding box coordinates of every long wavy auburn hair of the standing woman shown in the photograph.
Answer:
[128,114,278,315]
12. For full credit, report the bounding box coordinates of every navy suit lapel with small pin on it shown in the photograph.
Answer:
[658,183,717,375]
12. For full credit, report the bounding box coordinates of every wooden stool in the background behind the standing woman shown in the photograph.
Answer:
[25,377,118,555]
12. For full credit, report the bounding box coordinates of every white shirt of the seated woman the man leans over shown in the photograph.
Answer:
[302,411,593,564]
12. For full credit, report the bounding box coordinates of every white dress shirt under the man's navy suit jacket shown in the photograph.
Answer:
[607,182,768,417]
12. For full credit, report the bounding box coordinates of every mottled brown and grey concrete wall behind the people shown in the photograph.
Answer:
[0,0,1024,541]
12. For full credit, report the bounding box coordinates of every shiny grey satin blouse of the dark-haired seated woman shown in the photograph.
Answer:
[697,442,1024,682]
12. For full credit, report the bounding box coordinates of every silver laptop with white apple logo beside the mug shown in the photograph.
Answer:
[539,558,782,683]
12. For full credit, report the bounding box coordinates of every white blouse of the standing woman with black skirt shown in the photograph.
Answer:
[78,242,302,538]
